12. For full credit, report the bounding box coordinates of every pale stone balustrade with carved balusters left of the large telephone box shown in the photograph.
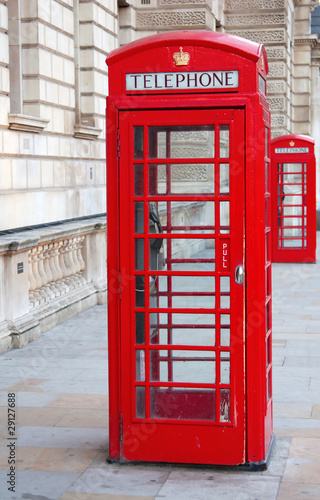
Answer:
[0,217,106,352]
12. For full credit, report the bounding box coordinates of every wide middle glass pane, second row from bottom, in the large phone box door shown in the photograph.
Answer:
[150,350,216,384]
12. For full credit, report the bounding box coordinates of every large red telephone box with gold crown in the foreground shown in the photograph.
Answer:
[107,31,272,467]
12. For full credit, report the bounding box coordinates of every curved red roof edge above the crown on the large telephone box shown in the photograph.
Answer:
[106,30,268,74]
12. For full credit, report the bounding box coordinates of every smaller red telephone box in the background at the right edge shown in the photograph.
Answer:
[271,135,317,262]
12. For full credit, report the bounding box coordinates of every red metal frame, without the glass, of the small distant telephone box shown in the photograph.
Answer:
[271,135,317,262]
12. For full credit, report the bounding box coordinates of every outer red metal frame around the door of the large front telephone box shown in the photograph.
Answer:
[107,32,272,464]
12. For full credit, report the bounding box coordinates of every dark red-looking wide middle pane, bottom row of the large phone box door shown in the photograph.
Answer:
[150,387,216,420]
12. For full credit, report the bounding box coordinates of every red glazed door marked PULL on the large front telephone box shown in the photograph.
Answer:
[119,109,245,464]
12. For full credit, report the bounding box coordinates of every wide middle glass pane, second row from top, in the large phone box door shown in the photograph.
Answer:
[149,163,214,196]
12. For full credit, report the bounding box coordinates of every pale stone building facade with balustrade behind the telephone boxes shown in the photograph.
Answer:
[0,0,320,350]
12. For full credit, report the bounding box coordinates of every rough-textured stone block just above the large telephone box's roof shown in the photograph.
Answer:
[137,10,213,29]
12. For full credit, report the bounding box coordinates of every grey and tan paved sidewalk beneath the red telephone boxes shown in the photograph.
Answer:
[0,245,320,500]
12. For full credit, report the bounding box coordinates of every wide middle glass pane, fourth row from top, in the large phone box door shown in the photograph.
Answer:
[149,238,215,271]
